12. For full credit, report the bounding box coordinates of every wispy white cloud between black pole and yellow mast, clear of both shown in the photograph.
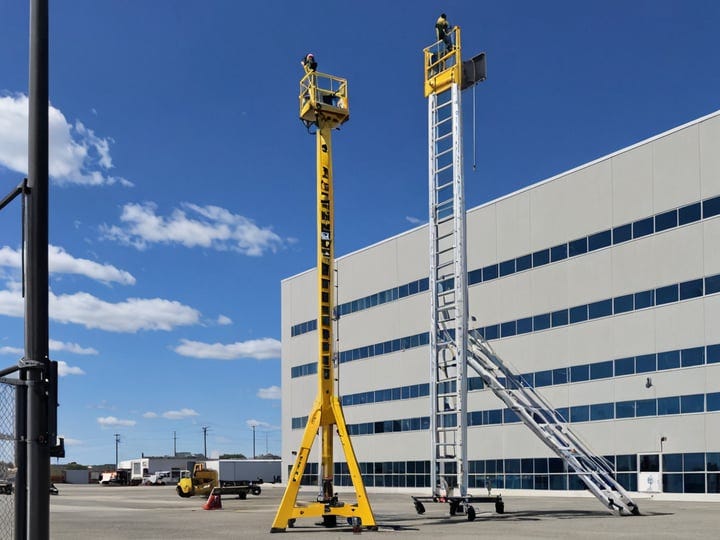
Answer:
[101,203,283,256]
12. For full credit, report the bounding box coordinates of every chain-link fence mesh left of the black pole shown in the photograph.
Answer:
[0,379,16,539]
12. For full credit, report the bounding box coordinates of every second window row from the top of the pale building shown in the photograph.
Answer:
[290,274,720,380]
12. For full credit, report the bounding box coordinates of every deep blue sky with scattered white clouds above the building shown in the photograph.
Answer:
[0,0,720,463]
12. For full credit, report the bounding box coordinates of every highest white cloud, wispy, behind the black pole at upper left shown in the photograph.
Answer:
[0,94,132,186]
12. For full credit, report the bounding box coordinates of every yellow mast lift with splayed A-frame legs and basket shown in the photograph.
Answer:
[270,72,377,532]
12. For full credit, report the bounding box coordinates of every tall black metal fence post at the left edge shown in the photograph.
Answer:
[22,0,50,540]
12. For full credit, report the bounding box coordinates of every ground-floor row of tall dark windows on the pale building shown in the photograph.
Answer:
[292,452,720,493]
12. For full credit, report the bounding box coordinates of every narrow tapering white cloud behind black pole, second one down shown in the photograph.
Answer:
[0,245,135,285]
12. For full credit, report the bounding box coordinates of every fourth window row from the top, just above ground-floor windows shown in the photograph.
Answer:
[291,392,720,435]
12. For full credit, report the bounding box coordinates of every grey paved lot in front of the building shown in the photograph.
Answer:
[50,484,720,540]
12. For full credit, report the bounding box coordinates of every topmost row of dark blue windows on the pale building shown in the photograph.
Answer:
[290,197,720,339]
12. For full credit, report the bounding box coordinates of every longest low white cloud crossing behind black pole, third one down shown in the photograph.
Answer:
[0,284,200,333]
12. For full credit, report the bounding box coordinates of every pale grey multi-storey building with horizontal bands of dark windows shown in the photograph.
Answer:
[281,111,720,496]
